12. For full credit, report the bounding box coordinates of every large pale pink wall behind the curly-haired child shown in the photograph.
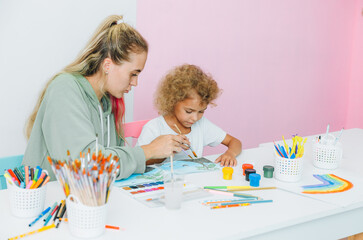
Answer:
[134,0,356,153]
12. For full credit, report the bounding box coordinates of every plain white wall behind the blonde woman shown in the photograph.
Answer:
[0,0,136,157]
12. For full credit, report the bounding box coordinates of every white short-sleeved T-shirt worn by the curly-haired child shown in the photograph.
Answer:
[136,116,227,160]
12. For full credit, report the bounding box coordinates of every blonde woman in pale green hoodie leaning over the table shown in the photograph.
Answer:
[23,15,189,180]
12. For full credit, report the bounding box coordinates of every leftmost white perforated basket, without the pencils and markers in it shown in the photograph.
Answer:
[7,182,47,218]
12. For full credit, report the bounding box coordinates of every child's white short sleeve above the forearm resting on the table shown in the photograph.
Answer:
[201,117,227,147]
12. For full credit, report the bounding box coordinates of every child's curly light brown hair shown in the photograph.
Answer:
[155,64,221,115]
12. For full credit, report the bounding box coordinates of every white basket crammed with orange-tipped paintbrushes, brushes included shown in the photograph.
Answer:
[48,151,120,238]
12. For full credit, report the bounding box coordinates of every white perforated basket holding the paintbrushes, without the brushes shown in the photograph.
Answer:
[66,194,107,238]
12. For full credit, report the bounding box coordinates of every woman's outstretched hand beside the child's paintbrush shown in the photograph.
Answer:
[141,134,190,160]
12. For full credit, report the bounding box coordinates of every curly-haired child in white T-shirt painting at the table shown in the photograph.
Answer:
[137,65,242,166]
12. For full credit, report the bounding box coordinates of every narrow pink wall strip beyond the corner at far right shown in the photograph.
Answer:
[346,0,363,128]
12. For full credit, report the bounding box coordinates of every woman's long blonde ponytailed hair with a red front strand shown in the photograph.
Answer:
[25,15,148,139]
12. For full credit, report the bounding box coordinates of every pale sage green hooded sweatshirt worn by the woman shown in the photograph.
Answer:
[23,73,146,180]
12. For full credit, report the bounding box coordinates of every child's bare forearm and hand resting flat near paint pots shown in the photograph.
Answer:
[215,134,242,167]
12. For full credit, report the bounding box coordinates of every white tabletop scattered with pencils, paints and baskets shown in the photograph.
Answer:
[0,129,363,240]
